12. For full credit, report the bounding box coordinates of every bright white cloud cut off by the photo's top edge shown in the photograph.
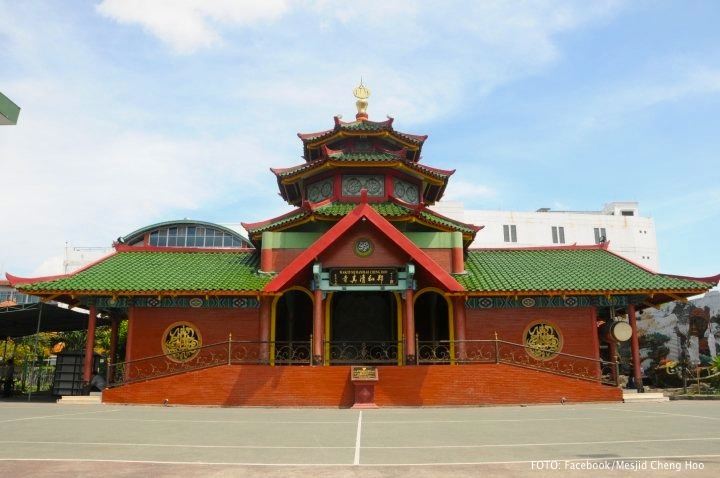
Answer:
[97,0,288,53]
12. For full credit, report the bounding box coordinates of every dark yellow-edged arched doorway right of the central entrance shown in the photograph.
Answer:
[414,290,454,363]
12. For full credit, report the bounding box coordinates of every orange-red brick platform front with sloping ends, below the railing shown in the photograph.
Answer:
[103,364,623,407]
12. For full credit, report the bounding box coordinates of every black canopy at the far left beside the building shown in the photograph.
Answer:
[0,303,110,339]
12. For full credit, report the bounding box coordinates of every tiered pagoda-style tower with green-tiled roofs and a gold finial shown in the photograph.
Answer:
[243,82,480,254]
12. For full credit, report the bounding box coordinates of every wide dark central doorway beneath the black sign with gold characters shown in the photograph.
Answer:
[326,291,400,364]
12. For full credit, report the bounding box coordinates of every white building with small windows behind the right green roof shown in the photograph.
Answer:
[432,201,659,271]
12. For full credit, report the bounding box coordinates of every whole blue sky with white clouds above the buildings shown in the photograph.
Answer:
[0,0,720,275]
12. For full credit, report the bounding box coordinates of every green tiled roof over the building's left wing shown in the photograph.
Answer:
[18,251,270,294]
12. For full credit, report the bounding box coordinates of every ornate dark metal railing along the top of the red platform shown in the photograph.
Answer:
[107,337,619,387]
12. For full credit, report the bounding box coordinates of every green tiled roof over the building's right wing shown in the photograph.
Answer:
[455,248,712,293]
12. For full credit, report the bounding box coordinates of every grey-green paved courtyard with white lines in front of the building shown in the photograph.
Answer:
[0,401,720,477]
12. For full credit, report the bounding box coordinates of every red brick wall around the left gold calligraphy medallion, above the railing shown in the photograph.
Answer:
[128,307,260,360]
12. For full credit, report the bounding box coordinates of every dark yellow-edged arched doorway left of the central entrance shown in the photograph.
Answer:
[272,289,313,364]
